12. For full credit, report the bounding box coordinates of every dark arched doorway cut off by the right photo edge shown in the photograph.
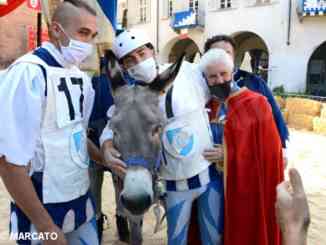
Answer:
[306,42,326,96]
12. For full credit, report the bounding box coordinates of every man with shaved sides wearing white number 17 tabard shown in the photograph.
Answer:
[0,0,98,245]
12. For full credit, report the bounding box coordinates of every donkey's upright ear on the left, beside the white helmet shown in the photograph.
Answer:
[105,50,127,91]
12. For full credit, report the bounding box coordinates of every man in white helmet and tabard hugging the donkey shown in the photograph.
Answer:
[101,30,223,245]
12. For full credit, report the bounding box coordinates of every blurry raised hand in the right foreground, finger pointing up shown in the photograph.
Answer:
[275,169,310,245]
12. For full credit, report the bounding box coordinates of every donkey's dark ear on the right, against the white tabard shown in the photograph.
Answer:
[149,54,185,92]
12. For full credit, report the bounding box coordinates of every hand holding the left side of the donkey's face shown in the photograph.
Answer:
[102,140,127,178]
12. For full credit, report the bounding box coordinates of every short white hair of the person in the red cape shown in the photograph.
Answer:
[199,48,234,73]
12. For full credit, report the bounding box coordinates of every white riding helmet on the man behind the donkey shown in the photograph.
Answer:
[112,29,151,59]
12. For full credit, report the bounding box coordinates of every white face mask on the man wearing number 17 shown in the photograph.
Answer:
[56,26,93,65]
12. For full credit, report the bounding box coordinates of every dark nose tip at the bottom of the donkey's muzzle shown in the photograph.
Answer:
[120,194,152,215]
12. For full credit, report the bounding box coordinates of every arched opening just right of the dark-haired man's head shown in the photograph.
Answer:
[232,31,269,81]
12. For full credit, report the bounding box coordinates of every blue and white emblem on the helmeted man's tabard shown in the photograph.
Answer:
[166,128,194,157]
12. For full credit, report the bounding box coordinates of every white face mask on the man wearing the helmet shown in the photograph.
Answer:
[127,57,158,83]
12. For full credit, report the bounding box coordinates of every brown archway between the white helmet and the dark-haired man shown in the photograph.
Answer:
[169,38,199,63]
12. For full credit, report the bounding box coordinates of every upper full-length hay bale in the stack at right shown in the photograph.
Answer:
[286,98,322,117]
